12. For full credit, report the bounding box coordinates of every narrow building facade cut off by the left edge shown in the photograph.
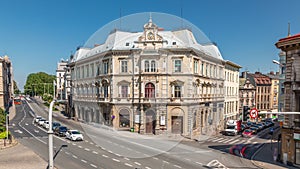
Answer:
[0,56,14,110]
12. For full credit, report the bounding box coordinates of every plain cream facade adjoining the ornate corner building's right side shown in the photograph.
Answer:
[224,61,241,121]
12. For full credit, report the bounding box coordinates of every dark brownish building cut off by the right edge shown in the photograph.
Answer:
[275,34,300,164]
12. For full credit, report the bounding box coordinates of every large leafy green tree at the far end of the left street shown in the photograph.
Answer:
[24,72,56,96]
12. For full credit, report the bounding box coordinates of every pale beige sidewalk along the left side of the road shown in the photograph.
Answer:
[0,101,48,169]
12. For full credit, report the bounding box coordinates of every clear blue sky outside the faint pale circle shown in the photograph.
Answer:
[0,0,300,89]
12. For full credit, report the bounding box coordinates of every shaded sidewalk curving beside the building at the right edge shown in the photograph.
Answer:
[251,141,299,169]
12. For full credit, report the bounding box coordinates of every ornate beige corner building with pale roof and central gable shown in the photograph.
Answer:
[69,18,232,138]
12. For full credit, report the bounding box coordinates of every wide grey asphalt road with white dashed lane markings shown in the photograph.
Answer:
[11,98,255,169]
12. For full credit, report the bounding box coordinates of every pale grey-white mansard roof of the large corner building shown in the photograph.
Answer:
[74,22,223,61]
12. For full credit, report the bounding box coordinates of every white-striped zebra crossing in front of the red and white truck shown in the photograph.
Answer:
[205,136,253,144]
